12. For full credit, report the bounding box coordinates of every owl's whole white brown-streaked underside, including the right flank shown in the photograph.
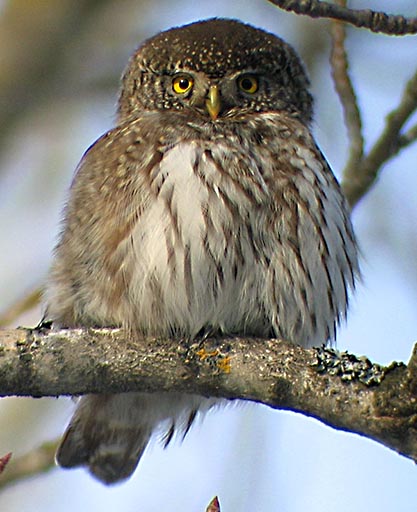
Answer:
[109,134,355,345]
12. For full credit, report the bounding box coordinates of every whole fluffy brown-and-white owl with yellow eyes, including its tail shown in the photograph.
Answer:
[46,19,357,483]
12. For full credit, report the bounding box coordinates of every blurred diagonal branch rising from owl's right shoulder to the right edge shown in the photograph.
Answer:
[342,71,417,207]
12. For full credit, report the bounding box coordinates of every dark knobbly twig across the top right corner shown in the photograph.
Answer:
[268,0,417,36]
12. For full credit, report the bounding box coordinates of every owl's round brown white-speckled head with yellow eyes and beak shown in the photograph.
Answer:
[119,18,312,123]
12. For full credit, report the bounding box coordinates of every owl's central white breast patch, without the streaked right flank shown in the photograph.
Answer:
[130,142,271,336]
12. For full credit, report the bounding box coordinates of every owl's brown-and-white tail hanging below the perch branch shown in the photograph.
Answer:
[56,393,217,484]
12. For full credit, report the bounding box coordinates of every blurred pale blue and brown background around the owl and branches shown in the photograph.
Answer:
[0,0,417,512]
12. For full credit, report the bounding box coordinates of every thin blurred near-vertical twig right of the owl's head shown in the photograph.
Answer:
[330,0,364,182]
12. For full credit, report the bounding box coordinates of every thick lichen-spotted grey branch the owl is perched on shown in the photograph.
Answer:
[0,329,417,461]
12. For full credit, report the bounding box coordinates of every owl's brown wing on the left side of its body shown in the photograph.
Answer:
[45,119,161,327]
